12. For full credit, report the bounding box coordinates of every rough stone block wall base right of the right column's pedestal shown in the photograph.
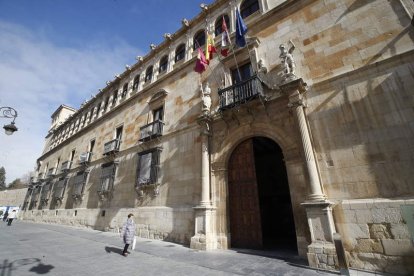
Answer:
[334,199,414,274]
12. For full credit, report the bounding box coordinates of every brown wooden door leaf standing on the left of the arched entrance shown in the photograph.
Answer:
[228,139,262,248]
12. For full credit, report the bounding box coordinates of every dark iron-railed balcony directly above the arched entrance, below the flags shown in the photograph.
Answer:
[218,76,263,110]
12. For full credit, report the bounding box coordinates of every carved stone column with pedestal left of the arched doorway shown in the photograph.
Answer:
[190,115,217,250]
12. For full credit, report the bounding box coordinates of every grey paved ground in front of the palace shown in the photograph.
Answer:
[0,220,338,276]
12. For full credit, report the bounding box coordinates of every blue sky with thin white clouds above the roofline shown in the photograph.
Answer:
[0,0,213,183]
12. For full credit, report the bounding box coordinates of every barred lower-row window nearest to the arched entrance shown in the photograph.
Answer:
[137,148,161,186]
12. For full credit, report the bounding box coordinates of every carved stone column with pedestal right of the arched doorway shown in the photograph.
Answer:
[280,78,338,269]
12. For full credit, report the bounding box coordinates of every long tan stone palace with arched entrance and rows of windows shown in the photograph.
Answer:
[21,0,414,274]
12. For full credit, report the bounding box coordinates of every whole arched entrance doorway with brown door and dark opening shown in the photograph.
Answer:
[228,137,297,251]
